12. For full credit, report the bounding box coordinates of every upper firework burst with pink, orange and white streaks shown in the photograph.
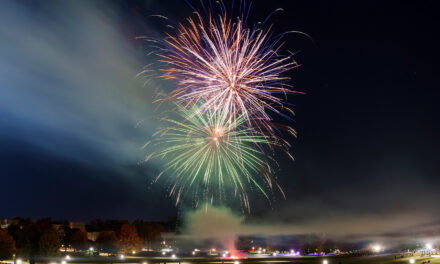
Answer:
[160,10,297,134]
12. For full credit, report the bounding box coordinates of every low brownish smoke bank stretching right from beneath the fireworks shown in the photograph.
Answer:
[180,205,440,249]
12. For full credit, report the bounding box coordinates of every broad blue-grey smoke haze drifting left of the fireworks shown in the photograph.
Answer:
[0,1,160,164]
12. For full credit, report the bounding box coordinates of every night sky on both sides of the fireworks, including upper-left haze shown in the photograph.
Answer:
[0,0,440,239]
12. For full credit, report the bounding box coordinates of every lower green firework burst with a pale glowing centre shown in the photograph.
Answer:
[147,104,281,209]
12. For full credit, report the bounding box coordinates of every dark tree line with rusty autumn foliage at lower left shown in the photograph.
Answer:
[0,218,176,262]
